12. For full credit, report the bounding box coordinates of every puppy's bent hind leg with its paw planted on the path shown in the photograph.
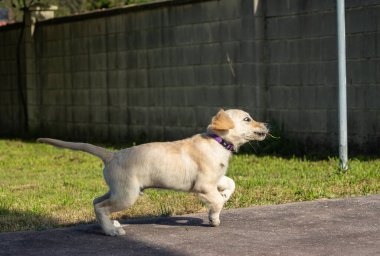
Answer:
[94,189,140,236]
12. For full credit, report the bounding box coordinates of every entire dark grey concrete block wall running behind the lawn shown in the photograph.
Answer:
[0,0,380,153]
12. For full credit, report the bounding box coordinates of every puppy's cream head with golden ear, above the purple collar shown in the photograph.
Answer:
[207,109,269,148]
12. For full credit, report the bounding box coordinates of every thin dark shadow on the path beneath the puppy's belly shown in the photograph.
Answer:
[120,216,209,227]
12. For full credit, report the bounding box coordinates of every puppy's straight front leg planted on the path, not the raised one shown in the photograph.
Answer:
[199,188,224,227]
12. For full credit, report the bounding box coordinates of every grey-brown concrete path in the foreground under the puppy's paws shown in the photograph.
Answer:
[0,195,380,256]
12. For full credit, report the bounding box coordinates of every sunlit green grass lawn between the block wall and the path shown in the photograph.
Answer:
[0,140,380,232]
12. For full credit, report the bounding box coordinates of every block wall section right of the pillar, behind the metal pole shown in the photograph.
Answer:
[266,0,380,153]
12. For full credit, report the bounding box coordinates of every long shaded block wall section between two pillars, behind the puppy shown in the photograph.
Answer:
[31,0,265,142]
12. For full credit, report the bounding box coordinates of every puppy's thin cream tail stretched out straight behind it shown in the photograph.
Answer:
[37,138,114,163]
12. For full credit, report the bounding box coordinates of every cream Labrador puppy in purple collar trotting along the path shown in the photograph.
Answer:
[37,109,268,236]
